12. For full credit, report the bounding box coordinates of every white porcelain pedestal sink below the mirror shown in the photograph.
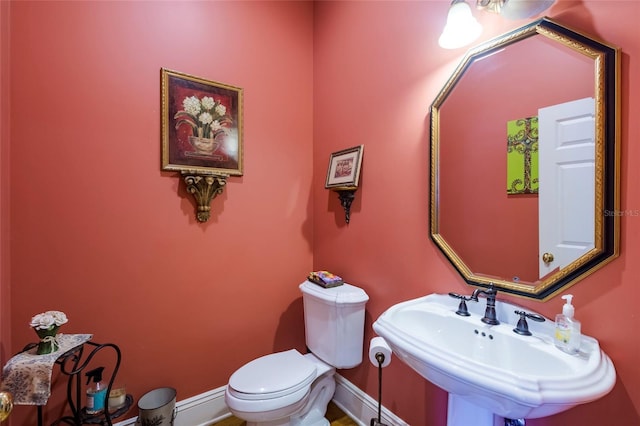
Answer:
[373,294,616,426]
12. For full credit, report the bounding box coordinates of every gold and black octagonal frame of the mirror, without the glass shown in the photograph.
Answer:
[430,17,620,300]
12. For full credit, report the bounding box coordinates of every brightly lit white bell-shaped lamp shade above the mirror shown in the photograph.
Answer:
[438,0,482,49]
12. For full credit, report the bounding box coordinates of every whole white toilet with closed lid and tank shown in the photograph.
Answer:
[225,281,369,426]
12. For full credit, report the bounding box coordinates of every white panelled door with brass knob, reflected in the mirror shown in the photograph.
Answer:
[538,98,596,278]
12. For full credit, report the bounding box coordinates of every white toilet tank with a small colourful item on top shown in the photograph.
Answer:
[300,281,369,368]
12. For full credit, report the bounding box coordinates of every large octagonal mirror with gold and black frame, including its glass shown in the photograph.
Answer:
[430,17,622,300]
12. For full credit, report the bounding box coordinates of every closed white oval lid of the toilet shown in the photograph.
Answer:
[229,349,316,399]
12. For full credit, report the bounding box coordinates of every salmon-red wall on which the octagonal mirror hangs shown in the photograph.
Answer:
[314,0,640,426]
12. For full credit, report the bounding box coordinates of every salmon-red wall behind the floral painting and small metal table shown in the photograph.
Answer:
[2,1,313,425]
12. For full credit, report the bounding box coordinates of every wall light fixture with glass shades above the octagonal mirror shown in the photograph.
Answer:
[438,0,555,49]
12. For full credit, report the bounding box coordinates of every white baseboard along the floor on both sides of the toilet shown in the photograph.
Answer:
[114,374,408,426]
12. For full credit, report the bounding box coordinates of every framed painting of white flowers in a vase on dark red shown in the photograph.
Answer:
[161,68,243,176]
